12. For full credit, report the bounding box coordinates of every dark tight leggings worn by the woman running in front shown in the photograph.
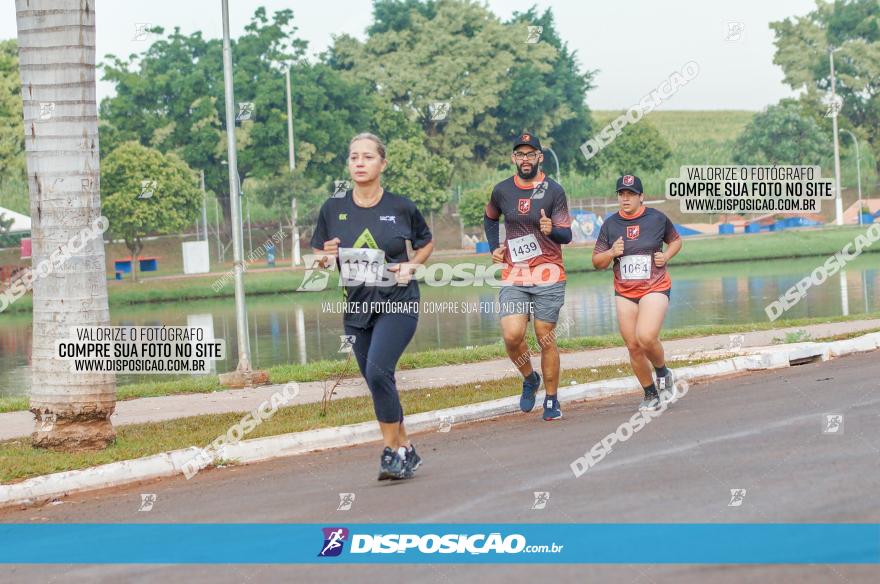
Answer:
[345,314,419,424]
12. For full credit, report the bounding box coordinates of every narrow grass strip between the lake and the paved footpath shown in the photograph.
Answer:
[0,312,880,413]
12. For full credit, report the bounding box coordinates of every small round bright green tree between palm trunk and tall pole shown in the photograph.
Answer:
[104,142,202,281]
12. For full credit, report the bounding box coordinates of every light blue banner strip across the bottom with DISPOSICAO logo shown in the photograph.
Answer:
[0,522,880,564]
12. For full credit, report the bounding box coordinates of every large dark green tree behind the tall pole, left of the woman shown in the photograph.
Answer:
[101,8,377,225]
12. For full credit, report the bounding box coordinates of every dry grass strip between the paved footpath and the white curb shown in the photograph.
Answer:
[0,360,706,483]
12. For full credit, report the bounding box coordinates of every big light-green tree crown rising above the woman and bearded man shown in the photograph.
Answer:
[328,0,556,168]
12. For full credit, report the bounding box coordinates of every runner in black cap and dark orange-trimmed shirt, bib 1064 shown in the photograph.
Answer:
[593,174,681,410]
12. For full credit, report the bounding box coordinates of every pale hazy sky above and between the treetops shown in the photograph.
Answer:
[0,0,815,111]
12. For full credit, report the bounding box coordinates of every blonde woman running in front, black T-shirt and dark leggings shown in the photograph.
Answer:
[311,134,434,480]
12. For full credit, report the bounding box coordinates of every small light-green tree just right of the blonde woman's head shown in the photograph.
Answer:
[383,137,452,215]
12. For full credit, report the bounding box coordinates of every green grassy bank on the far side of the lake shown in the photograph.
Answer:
[6,227,880,312]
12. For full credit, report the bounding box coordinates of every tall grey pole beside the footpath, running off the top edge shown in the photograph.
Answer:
[222,0,251,374]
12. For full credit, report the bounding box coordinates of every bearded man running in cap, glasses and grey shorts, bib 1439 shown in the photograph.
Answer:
[483,133,571,421]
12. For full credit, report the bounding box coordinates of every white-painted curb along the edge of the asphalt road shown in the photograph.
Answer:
[0,333,880,507]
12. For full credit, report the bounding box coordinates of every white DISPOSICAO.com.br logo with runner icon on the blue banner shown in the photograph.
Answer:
[318,527,563,557]
